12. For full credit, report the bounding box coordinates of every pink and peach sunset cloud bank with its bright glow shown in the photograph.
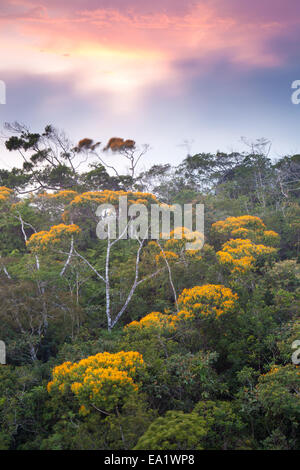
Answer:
[0,0,300,107]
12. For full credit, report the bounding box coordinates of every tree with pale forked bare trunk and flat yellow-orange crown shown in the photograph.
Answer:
[22,191,188,330]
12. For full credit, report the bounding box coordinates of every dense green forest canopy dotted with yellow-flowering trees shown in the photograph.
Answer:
[0,123,300,450]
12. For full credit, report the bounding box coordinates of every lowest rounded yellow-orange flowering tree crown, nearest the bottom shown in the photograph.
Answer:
[47,351,145,415]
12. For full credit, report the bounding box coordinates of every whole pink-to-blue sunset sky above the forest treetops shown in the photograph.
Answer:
[0,0,300,173]
